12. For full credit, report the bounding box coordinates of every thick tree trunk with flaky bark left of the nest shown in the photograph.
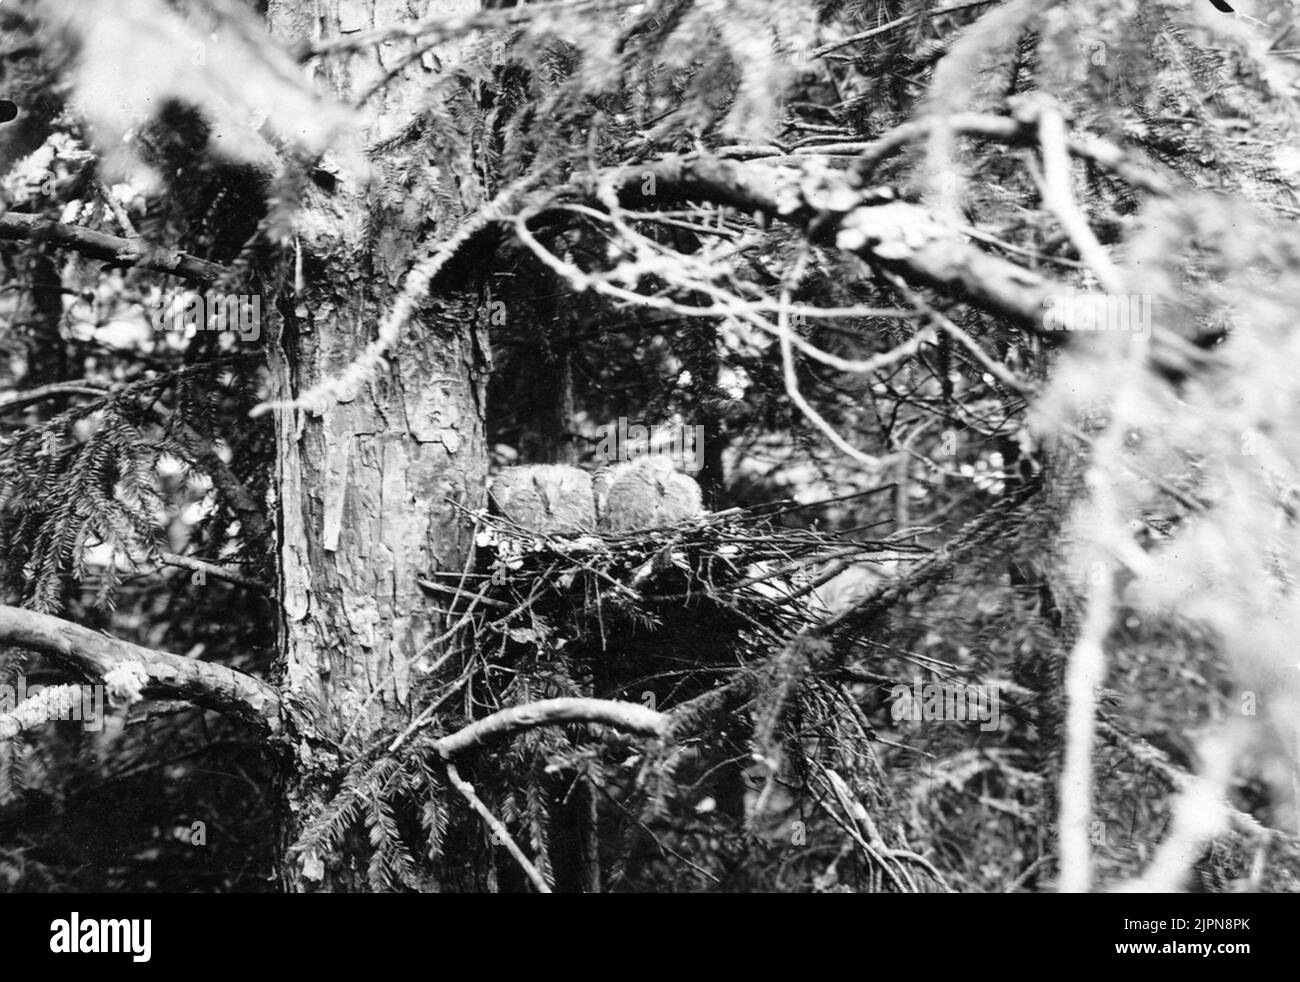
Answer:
[264,0,488,891]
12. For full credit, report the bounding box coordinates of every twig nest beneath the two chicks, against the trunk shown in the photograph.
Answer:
[425,489,930,691]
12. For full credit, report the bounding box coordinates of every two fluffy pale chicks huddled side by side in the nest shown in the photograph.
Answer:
[488,457,705,535]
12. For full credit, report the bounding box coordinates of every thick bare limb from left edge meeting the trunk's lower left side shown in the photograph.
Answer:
[0,605,280,734]
